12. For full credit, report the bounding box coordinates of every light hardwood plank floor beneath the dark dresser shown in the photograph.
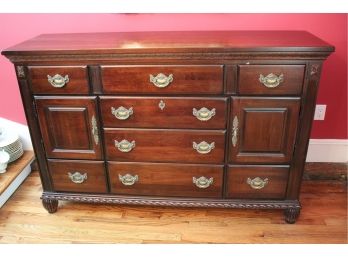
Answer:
[0,168,347,243]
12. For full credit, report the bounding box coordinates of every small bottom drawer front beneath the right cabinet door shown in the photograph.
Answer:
[226,165,289,199]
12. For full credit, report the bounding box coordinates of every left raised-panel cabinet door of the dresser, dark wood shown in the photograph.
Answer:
[36,97,101,159]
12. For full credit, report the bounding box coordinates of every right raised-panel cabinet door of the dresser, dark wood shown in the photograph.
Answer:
[230,97,300,163]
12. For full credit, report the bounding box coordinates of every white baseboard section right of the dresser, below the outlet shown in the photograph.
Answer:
[306,139,348,162]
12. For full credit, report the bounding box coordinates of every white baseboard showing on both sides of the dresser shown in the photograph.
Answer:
[0,118,348,162]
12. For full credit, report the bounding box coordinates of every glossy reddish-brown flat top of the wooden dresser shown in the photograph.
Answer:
[2,31,334,55]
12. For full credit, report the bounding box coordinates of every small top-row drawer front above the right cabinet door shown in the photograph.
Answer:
[238,65,305,95]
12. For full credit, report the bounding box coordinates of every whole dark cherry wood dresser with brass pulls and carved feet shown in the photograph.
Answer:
[2,31,334,223]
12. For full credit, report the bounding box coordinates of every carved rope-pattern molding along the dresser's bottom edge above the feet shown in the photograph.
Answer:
[41,192,301,209]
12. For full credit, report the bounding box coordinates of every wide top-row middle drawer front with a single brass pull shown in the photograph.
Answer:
[101,65,223,94]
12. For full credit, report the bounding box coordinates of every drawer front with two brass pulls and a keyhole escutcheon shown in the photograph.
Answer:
[101,97,227,129]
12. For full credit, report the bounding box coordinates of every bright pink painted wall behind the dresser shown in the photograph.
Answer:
[0,14,348,139]
